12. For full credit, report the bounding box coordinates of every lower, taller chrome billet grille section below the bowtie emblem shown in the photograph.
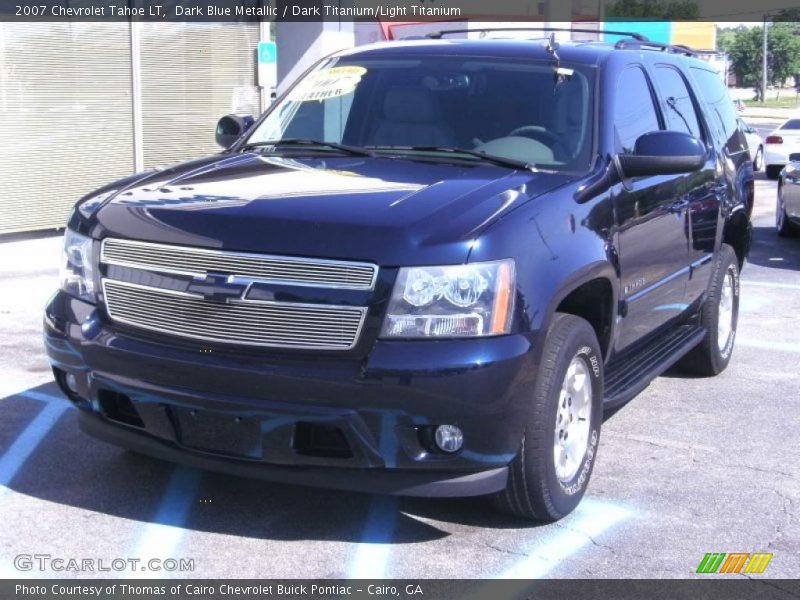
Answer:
[103,279,367,350]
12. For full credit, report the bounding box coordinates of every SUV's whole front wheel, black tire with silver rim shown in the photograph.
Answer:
[492,313,603,521]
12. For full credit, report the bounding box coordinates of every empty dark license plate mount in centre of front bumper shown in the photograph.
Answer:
[171,407,264,459]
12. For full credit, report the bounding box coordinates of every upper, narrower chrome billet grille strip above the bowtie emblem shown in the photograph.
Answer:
[100,238,378,290]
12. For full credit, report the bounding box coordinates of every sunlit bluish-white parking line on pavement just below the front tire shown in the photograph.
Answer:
[496,498,632,579]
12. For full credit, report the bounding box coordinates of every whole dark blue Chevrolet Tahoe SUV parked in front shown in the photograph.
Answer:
[45,35,753,520]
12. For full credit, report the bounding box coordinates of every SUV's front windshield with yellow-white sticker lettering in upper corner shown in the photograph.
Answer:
[247,56,594,171]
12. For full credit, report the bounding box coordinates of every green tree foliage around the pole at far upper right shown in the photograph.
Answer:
[717,22,800,87]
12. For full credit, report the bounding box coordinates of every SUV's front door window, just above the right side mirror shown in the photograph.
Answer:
[614,67,661,153]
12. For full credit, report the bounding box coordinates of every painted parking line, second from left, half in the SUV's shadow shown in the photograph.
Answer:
[131,466,202,578]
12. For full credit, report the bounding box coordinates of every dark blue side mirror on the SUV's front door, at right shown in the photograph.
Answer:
[617,131,706,177]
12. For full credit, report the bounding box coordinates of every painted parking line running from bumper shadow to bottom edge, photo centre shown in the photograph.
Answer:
[348,496,399,579]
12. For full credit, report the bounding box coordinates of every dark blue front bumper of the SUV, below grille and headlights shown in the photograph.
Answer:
[45,292,536,496]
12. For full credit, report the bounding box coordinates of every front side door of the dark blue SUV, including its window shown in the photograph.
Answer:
[612,64,689,350]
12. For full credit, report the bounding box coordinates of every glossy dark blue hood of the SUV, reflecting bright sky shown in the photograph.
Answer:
[90,153,569,266]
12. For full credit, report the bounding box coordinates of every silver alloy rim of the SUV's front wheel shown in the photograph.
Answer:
[553,355,592,483]
